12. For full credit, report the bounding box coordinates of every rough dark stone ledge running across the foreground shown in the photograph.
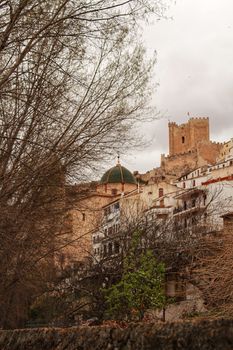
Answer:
[0,319,233,350]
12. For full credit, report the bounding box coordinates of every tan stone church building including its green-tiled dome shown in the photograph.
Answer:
[63,161,138,266]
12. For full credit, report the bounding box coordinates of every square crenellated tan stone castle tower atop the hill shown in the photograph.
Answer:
[168,118,210,156]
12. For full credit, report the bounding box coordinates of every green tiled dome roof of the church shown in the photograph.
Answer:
[100,164,137,184]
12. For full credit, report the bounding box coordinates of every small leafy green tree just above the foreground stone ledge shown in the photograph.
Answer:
[105,250,166,319]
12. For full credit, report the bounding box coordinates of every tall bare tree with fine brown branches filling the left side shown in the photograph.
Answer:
[0,0,167,327]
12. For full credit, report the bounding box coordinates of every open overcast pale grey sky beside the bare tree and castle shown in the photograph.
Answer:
[122,0,233,172]
